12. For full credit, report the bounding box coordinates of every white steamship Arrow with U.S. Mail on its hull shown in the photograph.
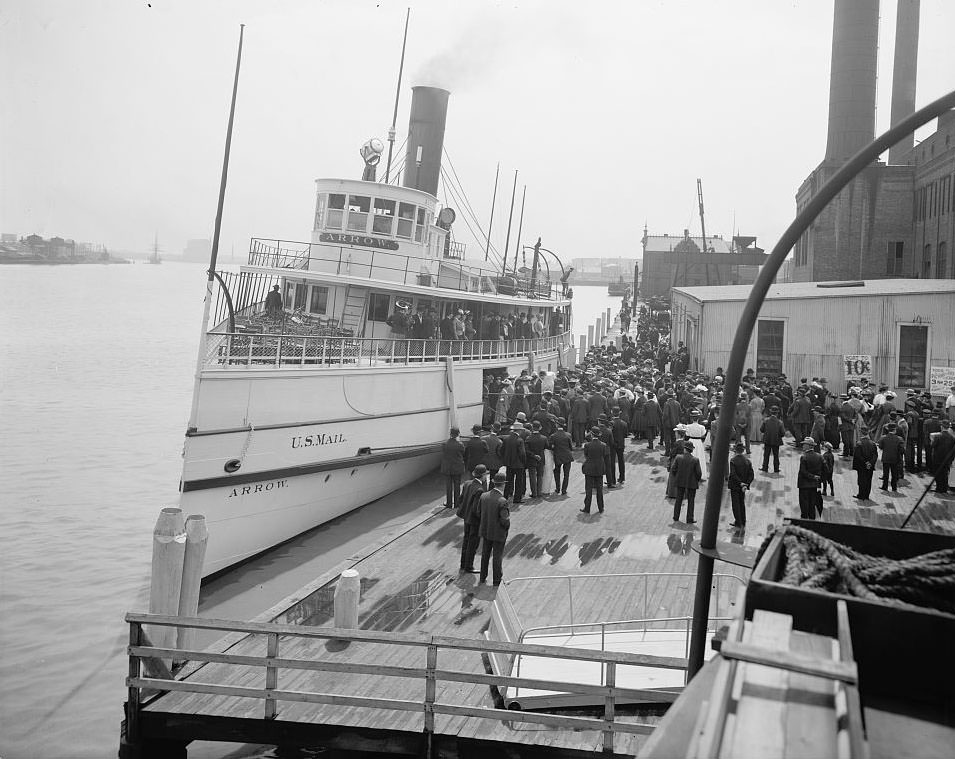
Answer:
[180,87,573,577]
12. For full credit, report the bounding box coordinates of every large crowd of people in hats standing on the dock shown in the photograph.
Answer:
[441,302,955,584]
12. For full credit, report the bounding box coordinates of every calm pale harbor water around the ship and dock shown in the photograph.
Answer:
[0,263,619,759]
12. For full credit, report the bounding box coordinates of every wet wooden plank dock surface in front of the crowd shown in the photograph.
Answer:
[129,424,955,756]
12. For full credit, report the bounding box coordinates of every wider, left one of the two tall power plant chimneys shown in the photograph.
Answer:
[826,0,879,162]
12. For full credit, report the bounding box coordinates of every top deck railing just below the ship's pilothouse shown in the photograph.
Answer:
[249,238,563,300]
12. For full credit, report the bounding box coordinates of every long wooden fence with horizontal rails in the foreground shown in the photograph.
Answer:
[125,613,668,751]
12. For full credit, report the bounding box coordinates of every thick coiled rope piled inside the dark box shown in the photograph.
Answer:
[756,525,955,614]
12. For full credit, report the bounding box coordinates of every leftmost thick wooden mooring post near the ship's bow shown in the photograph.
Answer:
[149,507,186,667]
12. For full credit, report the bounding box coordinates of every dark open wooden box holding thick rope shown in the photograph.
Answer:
[744,519,955,708]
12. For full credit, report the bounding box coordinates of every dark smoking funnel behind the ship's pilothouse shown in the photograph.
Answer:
[402,87,451,196]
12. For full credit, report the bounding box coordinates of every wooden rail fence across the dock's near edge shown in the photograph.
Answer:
[126,613,672,755]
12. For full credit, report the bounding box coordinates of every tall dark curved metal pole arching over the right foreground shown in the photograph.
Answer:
[687,91,955,678]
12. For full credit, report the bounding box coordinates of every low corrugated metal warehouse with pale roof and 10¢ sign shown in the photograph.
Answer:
[671,279,955,396]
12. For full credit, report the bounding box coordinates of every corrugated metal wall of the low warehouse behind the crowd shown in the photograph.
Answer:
[673,293,955,389]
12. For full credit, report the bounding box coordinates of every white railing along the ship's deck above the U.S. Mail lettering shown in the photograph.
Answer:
[205,332,572,369]
